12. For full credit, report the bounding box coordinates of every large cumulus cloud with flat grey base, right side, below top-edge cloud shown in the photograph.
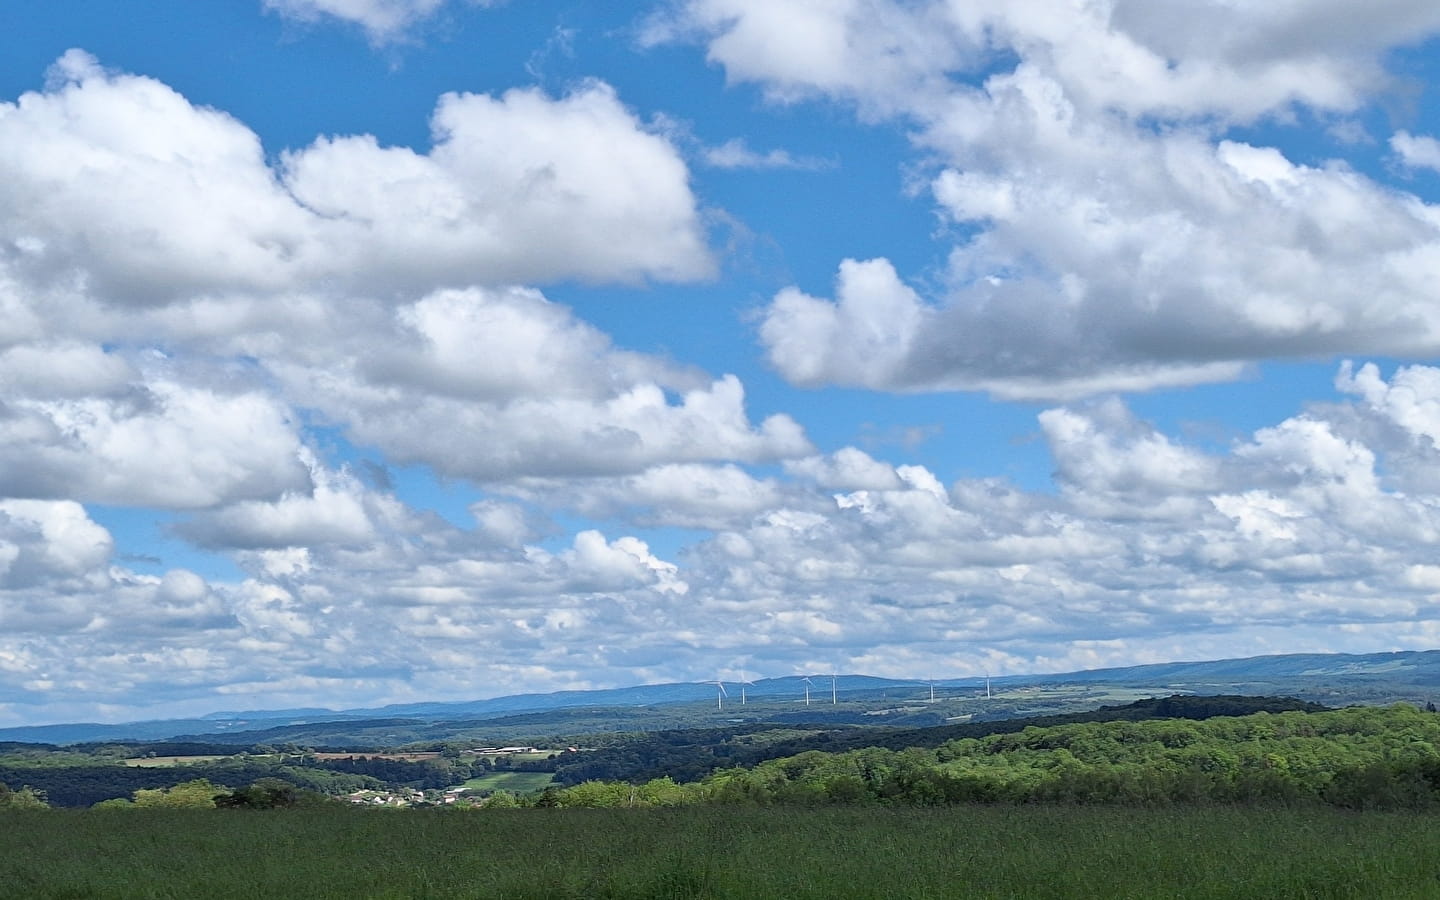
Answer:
[762,115,1440,397]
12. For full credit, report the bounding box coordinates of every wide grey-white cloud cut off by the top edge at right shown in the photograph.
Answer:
[665,0,1440,121]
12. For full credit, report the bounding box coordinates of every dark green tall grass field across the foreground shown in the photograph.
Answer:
[0,806,1440,900]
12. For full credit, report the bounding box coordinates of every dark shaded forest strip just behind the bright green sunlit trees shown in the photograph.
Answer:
[549,696,1326,785]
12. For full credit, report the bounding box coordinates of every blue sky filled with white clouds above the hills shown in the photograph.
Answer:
[0,0,1440,726]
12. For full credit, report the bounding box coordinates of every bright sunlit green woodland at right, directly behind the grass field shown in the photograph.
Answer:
[521,706,1440,809]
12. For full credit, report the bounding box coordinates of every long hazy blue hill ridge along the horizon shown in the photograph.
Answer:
[0,651,1440,746]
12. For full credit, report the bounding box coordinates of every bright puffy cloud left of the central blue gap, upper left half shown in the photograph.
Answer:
[284,82,711,284]
